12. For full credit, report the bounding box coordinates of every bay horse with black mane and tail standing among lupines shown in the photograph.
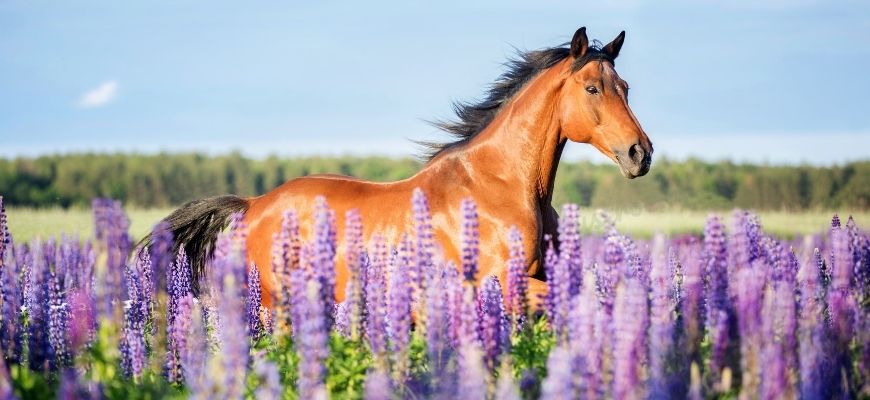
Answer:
[157,28,653,306]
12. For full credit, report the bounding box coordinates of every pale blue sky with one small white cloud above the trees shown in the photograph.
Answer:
[0,0,870,165]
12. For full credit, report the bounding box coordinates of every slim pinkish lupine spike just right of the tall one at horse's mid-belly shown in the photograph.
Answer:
[344,209,365,339]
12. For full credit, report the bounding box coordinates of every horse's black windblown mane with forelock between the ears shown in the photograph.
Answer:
[417,43,613,161]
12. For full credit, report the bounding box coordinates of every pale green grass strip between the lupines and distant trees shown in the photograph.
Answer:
[7,207,870,241]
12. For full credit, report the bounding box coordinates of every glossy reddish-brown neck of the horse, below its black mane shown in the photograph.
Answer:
[435,61,569,204]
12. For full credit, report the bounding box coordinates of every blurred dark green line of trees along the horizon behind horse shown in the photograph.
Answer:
[0,153,870,210]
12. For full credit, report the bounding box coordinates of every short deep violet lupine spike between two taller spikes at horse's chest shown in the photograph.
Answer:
[478,275,510,371]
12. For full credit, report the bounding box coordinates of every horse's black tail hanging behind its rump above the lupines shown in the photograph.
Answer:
[140,195,248,293]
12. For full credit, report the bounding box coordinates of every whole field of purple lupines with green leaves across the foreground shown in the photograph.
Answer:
[0,191,870,399]
